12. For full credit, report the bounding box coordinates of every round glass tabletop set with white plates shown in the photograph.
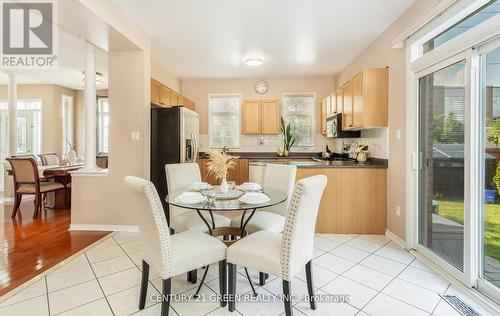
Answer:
[165,187,287,211]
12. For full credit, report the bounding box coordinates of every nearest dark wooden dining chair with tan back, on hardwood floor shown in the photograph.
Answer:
[7,157,64,218]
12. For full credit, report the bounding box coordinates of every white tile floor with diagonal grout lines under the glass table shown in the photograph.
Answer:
[0,233,494,316]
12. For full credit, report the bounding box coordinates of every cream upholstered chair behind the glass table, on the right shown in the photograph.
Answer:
[231,164,297,234]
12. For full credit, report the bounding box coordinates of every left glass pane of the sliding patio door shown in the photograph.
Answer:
[418,60,466,271]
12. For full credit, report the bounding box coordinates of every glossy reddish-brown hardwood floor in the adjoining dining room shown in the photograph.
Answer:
[0,199,109,296]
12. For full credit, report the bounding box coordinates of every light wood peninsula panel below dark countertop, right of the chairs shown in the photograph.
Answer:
[297,168,387,234]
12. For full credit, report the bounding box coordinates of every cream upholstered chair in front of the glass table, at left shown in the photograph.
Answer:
[125,176,227,316]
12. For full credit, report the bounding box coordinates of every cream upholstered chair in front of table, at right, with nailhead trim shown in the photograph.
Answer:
[227,175,327,316]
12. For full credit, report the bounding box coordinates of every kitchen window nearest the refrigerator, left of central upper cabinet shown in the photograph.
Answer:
[208,94,241,148]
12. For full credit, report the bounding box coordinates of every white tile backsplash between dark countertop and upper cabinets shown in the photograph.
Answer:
[200,128,389,159]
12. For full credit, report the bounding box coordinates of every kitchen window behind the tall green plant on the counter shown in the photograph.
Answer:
[282,93,316,147]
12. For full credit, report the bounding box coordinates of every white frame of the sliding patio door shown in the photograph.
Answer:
[405,7,500,303]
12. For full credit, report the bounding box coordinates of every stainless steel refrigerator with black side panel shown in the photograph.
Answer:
[150,105,200,218]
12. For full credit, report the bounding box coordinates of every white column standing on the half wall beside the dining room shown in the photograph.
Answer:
[84,42,97,170]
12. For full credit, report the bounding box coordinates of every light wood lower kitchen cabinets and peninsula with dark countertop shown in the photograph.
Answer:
[199,152,388,234]
